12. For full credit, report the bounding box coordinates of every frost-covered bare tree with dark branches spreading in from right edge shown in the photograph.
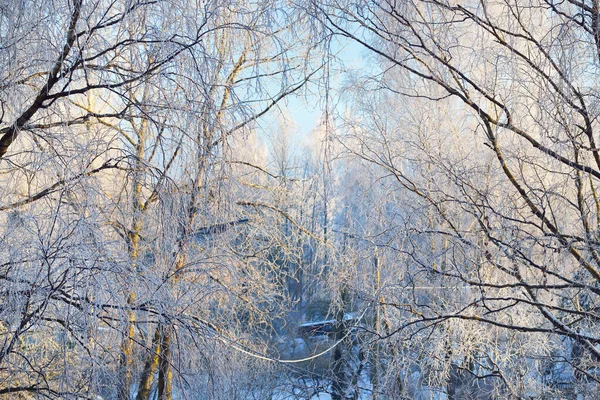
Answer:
[310,1,600,397]
